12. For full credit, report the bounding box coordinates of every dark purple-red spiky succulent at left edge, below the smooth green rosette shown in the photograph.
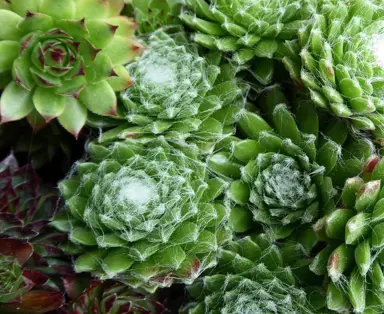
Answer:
[0,155,73,279]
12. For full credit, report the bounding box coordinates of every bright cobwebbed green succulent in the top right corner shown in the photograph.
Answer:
[283,0,384,140]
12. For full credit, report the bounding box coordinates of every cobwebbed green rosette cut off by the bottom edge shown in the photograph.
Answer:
[182,234,316,314]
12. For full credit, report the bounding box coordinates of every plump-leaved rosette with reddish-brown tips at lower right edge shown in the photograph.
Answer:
[310,156,384,313]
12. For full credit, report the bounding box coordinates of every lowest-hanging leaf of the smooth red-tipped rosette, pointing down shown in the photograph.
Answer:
[58,97,87,139]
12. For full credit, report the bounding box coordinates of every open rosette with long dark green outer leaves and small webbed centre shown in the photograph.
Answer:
[207,85,374,239]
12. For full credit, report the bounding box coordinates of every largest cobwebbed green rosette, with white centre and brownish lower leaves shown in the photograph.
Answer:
[52,137,231,291]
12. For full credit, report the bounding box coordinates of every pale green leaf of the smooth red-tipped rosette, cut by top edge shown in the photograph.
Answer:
[39,0,76,20]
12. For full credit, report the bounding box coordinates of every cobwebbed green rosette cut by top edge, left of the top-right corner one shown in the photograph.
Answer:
[180,0,316,85]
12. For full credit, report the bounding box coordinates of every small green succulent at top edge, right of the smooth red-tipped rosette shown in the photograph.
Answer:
[132,0,183,33]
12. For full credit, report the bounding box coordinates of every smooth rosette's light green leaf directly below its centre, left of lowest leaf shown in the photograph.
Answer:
[33,87,68,122]
